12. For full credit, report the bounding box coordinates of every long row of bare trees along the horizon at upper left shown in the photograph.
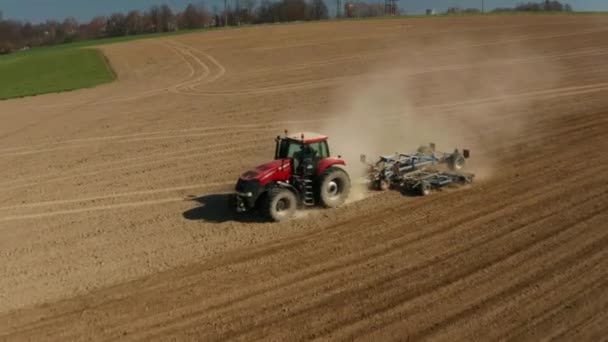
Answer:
[0,0,328,54]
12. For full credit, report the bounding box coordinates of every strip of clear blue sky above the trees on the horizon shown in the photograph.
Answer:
[0,0,608,22]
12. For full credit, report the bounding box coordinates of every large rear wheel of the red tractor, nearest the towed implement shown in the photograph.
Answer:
[317,167,350,208]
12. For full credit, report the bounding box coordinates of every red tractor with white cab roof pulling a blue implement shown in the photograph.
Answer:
[236,132,350,221]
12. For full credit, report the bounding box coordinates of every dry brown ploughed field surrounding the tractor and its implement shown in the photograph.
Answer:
[0,16,608,341]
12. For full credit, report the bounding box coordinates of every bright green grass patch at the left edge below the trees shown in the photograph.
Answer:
[0,47,116,100]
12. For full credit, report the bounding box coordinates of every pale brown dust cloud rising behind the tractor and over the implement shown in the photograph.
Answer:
[321,38,557,194]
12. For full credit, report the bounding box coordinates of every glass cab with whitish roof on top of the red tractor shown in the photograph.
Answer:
[275,132,329,176]
